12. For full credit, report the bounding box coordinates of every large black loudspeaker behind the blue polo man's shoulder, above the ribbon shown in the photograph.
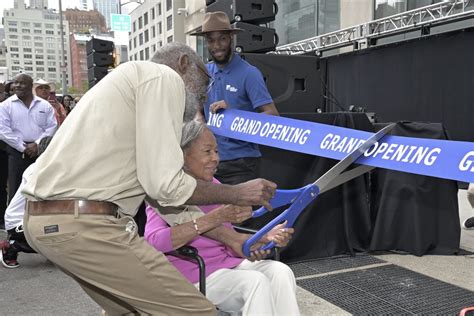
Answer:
[241,53,324,113]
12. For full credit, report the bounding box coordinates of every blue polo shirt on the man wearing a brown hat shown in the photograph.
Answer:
[204,54,273,161]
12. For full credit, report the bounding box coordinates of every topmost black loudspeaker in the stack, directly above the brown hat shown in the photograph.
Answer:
[206,0,278,24]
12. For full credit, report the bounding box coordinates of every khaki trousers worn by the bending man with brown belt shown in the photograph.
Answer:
[24,212,216,315]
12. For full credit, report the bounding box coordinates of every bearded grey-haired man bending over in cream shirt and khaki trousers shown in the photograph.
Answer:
[23,43,276,315]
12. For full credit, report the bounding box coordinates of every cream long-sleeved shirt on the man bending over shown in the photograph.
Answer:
[23,61,196,215]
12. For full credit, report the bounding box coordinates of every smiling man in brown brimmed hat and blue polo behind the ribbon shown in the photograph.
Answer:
[191,12,279,184]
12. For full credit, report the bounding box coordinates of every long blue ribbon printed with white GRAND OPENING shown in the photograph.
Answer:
[207,110,474,182]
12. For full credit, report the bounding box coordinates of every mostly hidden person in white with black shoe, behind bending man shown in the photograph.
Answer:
[0,136,52,269]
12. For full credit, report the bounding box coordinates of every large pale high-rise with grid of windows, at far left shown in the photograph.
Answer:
[3,0,71,87]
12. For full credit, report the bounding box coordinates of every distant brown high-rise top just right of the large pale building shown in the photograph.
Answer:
[64,9,107,33]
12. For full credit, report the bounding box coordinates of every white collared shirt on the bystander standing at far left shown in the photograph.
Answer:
[0,95,57,152]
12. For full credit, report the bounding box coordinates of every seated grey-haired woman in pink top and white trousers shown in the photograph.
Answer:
[145,121,299,315]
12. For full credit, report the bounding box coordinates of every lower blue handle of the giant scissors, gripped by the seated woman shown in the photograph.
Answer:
[242,184,319,257]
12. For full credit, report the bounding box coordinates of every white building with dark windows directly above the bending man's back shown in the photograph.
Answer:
[128,0,186,60]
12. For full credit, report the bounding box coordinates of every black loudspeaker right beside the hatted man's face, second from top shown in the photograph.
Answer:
[232,22,278,53]
